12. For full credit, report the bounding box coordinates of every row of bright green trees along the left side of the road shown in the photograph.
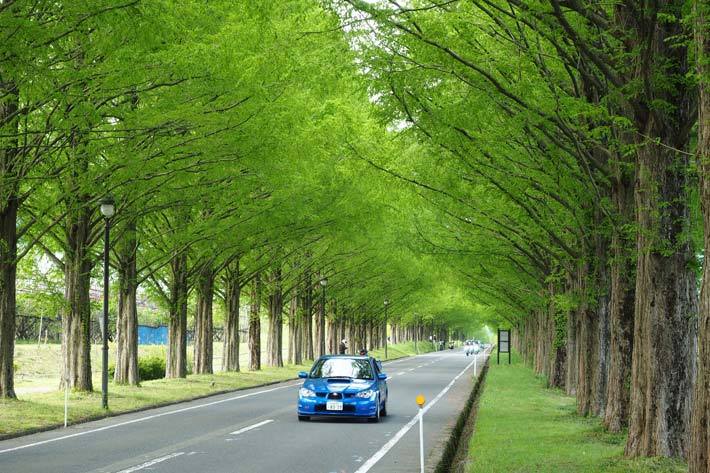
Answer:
[0,0,484,398]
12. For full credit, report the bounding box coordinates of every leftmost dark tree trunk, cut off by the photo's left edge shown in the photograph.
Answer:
[0,77,20,398]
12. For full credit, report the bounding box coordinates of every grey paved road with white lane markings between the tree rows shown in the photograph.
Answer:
[0,350,490,473]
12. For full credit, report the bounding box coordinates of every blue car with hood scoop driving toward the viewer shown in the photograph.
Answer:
[298,355,387,422]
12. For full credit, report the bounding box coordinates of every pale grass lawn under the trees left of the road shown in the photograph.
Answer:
[0,343,433,438]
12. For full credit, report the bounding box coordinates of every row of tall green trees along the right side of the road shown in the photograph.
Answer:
[339,0,710,466]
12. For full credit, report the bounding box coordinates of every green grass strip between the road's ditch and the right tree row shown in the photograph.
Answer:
[467,358,688,473]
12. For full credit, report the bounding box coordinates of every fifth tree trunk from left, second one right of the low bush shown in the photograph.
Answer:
[193,262,215,374]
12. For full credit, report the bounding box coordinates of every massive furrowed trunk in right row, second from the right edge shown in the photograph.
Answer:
[613,0,697,457]
